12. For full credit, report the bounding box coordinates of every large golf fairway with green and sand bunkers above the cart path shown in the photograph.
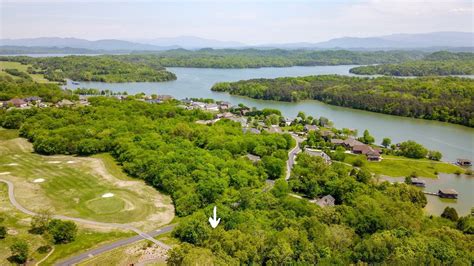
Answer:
[0,130,174,229]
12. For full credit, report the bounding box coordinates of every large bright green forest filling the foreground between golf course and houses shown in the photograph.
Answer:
[0,97,474,265]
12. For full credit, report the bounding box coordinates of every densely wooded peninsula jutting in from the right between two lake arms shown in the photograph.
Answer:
[212,75,474,127]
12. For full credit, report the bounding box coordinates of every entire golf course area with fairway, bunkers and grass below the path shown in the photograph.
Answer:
[0,128,174,265]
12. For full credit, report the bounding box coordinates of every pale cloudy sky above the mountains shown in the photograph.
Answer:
[0,0,474,44]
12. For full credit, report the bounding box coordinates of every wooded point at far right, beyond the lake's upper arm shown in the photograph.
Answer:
[349,52,474,76]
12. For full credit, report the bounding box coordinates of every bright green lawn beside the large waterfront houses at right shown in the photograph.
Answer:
[344,154,465,178]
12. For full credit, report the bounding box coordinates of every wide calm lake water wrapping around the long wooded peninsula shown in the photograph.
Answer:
[67,66,474,164]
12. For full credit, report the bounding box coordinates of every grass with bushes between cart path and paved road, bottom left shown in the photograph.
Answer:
[0,183,134,265]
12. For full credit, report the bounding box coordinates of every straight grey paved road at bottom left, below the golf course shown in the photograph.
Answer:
[56,224,175,266]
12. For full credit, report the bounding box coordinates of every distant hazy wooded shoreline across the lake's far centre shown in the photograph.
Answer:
[124,49,423,68]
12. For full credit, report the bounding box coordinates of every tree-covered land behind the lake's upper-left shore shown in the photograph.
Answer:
[0,55,176,82]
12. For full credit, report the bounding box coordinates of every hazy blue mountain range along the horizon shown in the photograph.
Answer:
[0,32,474,54]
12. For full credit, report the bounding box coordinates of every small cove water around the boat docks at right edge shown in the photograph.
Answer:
[383,173,474,216]
